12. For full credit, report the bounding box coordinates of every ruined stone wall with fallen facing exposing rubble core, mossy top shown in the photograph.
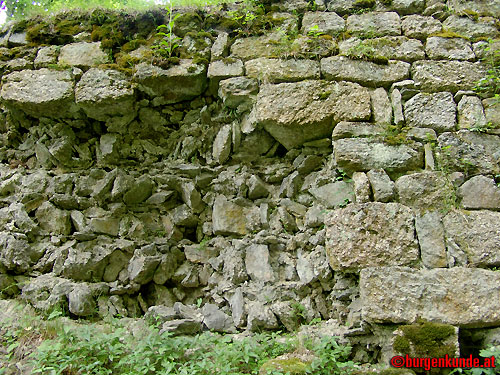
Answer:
[0,0,500,361]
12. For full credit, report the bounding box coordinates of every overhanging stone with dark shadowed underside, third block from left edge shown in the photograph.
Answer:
[134,59,207,104]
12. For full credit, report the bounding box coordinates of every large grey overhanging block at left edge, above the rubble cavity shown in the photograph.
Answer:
[0,68,76,117]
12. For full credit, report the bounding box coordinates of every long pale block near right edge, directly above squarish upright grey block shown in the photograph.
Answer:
[411,61,486,93]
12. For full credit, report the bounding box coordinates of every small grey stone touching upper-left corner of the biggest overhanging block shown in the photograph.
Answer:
[219,77,259,108]
